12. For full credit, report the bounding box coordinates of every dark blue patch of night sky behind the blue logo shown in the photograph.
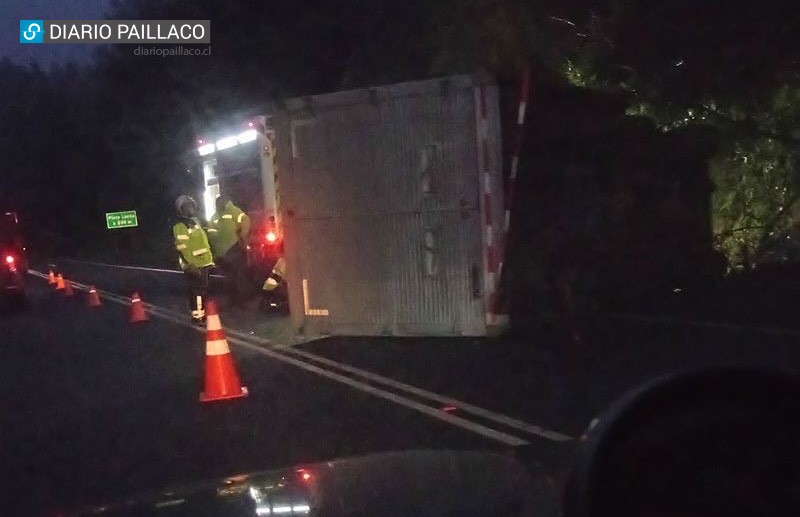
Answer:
[0,0,111,67]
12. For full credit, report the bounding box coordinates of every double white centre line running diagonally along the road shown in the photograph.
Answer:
[29,270,573,446]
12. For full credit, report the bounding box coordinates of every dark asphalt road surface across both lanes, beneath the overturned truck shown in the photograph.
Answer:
[9,261,800,515]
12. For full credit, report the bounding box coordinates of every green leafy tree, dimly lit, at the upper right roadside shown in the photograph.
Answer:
[562,0,800,263]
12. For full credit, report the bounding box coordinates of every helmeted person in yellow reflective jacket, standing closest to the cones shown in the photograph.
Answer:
[172,195,214,324]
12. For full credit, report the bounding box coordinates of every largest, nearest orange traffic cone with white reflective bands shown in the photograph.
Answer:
[200,300,248,402]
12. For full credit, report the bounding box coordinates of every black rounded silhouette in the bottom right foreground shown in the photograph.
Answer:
[564,369,800,517]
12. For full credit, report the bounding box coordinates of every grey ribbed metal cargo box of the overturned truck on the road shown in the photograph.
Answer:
[273,76,503,336]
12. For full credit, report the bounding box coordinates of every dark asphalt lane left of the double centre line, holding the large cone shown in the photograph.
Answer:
[0,278,544,515]
